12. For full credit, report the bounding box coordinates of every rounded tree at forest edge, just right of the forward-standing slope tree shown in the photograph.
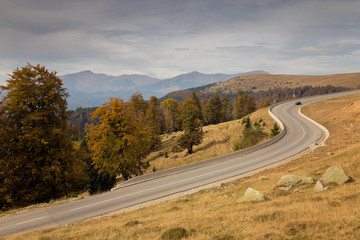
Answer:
[203,93,224,125]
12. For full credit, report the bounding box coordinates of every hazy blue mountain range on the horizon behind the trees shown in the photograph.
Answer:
[59,70,267,109]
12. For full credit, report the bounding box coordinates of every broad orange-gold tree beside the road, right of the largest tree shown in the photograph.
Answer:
[86,98,151,181]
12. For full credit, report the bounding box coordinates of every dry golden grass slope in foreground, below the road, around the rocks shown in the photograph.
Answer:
[4,95,360,240]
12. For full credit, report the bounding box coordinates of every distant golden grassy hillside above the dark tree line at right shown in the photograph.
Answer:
[206,73,360,93]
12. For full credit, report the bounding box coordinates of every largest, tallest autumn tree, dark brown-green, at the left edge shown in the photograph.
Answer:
[0,64,86,208]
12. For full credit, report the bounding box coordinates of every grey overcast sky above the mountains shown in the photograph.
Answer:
[0,0,360,83]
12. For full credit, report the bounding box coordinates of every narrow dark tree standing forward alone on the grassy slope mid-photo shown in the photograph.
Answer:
[177,97,203,154]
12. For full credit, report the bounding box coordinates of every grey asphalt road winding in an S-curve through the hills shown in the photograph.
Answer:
[0,91,360,236]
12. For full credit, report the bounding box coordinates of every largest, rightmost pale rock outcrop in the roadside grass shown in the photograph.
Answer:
[314,166,352,192]
